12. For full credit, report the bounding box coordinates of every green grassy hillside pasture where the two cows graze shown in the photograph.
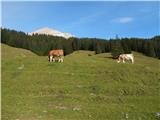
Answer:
[1,44,160,120]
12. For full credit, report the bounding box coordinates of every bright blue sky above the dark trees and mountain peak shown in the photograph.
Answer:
[1,1,160,39]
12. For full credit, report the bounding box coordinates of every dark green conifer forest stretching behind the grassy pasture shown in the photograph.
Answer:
[1,28,160,58]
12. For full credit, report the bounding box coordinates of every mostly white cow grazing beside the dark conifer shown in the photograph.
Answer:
[117,54,134,63]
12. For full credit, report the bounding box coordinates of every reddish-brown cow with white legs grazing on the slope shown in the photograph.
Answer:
[48,50,64,62]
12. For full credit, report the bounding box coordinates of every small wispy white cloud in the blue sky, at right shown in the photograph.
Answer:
[112,17,133,24]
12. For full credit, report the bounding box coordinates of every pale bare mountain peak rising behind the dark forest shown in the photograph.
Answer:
[28,27,75,39]
